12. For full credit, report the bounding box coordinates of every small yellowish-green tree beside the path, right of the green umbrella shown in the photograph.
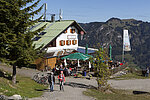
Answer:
[92,48,110,89]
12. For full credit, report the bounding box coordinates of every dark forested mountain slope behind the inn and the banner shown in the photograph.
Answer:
[79,18,150,67]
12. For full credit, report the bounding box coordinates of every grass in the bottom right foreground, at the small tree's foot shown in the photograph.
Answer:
[83,89,150,100]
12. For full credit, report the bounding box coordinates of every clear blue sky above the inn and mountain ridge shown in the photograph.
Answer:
[35,0,150,23]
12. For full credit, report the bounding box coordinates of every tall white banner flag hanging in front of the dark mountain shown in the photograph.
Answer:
[123,30,131,51]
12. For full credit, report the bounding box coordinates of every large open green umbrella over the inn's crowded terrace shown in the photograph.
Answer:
[61,52,89,60]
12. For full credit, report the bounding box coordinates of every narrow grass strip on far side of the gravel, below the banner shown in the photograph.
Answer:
[112,73,149,80]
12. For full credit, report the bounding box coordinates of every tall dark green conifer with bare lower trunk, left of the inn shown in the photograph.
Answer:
[0,0,46,83]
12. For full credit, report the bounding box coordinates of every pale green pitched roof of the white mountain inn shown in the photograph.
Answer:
[31,20,86,48]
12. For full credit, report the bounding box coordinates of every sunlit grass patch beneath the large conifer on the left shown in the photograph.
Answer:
[0,76,47,98]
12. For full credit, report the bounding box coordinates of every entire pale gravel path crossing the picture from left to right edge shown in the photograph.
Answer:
[0,65,150,100]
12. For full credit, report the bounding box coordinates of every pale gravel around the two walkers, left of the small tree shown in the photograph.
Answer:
[29,77,96,100]
